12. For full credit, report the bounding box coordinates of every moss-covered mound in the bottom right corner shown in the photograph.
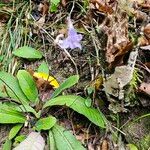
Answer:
[123,116,150,150]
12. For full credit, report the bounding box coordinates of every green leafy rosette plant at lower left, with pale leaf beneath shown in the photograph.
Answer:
[0,57,105,150]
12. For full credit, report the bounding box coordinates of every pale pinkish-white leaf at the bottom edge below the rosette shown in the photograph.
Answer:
[13,132,45,150]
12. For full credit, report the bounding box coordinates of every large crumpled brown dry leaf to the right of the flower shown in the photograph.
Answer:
[102,9,133,64]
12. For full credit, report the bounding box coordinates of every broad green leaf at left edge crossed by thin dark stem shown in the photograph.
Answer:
[0,71,29,103]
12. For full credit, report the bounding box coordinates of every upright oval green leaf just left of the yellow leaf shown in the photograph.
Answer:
[17,70,38,103]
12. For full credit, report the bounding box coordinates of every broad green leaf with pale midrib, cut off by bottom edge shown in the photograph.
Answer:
[52,124,85,150]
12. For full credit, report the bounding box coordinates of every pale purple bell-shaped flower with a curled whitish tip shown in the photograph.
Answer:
[56,17,82,49]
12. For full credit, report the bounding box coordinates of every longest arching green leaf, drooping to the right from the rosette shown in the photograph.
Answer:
[43,95,105,128]
